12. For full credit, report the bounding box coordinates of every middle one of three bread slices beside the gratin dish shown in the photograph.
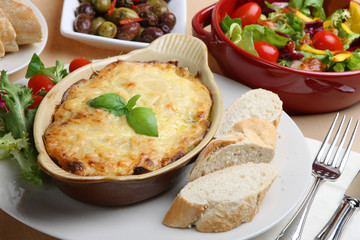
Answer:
[189,118,276,181]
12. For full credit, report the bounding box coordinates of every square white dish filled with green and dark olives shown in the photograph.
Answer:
[60,0,186,52]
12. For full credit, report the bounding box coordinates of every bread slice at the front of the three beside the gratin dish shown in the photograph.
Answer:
[163,163,278,232]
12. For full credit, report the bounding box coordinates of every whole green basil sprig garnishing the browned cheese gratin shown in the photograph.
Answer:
[87,93,159,137]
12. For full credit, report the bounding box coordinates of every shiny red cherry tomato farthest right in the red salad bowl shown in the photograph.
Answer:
[312,30,344,51]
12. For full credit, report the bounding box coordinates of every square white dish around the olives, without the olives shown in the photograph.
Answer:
[60,0,187,51]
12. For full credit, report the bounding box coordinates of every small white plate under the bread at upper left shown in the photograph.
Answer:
[0,0,48,74]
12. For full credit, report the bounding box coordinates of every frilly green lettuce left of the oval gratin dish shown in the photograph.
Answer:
[0,71,43,185]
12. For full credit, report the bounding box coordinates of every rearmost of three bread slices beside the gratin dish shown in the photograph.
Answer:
[214,88,282,138]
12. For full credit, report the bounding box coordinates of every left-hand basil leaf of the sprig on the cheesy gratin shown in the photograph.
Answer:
[87,93,129,116]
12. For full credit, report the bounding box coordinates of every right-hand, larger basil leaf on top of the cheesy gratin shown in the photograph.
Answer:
[126,107,159,137]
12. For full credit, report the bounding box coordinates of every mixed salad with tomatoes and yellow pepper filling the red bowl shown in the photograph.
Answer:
[220,0,360,72]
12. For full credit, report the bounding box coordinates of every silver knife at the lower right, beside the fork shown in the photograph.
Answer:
[314,171,360,240]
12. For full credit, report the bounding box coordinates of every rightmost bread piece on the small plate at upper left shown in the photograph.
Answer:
[0,0,42,45]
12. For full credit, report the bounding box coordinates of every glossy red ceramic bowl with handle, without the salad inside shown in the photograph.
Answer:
[192,0,360,113]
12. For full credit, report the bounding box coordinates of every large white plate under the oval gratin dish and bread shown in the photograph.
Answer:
[0,74,312,240]
